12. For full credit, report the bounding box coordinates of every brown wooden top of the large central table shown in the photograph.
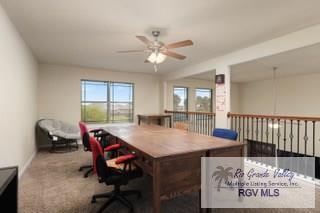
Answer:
[104,125,243,158]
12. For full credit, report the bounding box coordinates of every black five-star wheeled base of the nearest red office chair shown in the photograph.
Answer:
[91,186,141,213]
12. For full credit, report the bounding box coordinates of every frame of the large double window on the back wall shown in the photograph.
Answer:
[80,79,135,123]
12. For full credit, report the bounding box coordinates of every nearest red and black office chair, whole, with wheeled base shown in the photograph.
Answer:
[90,137,142,213]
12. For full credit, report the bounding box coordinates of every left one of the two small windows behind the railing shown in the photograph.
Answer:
[173,87,188,111]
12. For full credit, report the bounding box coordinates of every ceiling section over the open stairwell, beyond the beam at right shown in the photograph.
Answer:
[231,44,320,83]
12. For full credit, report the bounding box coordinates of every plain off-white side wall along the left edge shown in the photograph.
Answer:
[0,5,38,174]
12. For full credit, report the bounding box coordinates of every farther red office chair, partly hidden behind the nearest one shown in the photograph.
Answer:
[79,122,121,178]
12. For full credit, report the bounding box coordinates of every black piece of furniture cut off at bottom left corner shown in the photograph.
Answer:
[0,167,18,213]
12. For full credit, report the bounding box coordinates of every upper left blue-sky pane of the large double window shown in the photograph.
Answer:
[82,81,108,102]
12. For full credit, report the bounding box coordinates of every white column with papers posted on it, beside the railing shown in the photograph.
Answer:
[216,65,231,128]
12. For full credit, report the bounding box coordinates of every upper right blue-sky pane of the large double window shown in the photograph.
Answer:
[111,83,133,102]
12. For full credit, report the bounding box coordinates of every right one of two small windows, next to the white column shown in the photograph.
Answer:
[196,89,212,112]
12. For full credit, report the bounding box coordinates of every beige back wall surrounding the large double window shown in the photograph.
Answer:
[38,64,160,124]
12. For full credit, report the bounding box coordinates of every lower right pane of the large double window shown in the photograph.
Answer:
[110,102,133,122]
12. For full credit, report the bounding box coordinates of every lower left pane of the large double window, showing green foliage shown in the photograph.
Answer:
[81,103,107,122]
